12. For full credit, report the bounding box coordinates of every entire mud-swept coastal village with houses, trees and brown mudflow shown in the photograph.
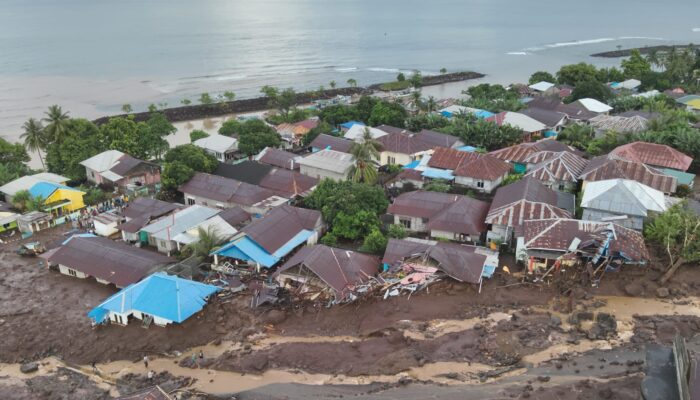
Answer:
[0,49,700,400]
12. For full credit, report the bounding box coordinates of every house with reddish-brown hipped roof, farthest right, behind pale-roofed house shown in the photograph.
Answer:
[610,142,693,171]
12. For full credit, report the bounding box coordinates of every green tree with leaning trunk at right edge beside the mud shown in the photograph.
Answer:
[644,204,700,284]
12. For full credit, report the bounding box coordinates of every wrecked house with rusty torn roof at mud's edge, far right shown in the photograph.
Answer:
[515,218,650,269]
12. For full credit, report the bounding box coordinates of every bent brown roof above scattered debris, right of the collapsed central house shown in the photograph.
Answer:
[382,239,486,284]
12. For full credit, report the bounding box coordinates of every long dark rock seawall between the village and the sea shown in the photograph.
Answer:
[92,71,486,125]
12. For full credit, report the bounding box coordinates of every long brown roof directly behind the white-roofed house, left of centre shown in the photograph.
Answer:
[178,172,273,206]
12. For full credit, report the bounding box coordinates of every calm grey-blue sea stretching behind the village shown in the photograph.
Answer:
[0,0,700,144]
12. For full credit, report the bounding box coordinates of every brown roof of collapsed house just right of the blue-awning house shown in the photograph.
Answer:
[275,244,379,297]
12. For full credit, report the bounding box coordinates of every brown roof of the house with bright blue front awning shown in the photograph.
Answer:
[242,204,321,254]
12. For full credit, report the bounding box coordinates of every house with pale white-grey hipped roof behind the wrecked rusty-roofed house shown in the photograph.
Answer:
[581,179,671,231]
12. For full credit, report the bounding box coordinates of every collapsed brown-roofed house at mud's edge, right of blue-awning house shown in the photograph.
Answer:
[273,244,380,301]
